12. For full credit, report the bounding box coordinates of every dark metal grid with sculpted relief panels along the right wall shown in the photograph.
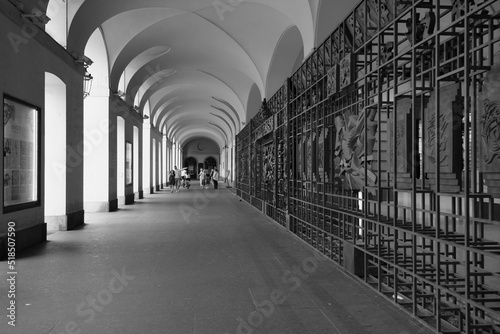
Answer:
[237,0,500,334]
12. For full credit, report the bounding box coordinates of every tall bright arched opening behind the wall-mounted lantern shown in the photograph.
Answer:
[83,29,110,212]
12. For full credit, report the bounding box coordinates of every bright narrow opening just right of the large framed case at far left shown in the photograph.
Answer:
[44,73,67,231]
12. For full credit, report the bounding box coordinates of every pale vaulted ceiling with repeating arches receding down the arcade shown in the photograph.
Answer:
[38,0,353,147]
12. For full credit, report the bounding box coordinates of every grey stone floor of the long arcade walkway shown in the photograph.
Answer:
[0,187,429,334]
